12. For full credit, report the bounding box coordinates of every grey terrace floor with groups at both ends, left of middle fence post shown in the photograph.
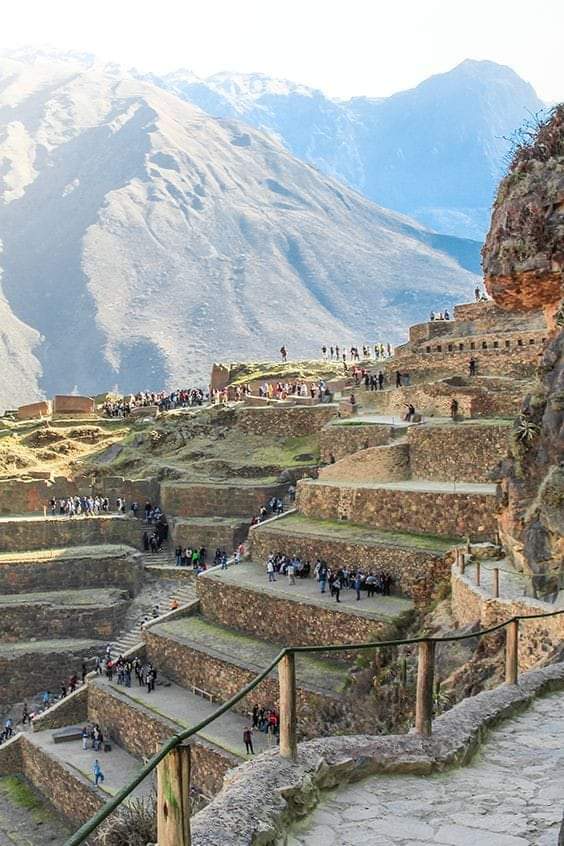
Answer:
[94,668,272,758]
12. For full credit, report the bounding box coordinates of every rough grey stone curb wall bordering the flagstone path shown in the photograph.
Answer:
[191,664,564,846]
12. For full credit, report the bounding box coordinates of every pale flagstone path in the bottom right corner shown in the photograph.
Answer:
[285,693,564,846]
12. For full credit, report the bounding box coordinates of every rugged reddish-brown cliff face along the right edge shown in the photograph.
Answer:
[483,105,564,593]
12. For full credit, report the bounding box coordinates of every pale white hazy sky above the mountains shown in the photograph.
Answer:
[4,0,564,100]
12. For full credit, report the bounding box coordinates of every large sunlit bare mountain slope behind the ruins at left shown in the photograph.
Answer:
[0,57,476,405]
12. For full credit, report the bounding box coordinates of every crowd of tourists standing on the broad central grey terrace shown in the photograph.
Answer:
[266,552,394,602]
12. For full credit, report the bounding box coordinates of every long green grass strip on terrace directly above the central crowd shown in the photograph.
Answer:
[255,513,460,553]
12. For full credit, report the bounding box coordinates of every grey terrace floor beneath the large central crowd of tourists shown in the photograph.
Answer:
[205,561,413,620]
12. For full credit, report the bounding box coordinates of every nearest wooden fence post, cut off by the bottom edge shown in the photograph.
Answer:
[157,743,191,846]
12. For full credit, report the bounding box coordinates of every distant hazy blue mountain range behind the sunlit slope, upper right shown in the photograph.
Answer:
[154,60,544,240]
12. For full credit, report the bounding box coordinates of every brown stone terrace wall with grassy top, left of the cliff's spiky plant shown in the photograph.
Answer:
[408,423,510,482]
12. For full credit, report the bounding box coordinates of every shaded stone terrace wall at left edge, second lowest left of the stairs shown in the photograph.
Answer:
[0,592,129,643]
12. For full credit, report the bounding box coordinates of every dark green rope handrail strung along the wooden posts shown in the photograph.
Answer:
[65,608,564,846]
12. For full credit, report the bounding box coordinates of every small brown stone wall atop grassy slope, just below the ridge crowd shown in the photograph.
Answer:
[236,405,337,438]
